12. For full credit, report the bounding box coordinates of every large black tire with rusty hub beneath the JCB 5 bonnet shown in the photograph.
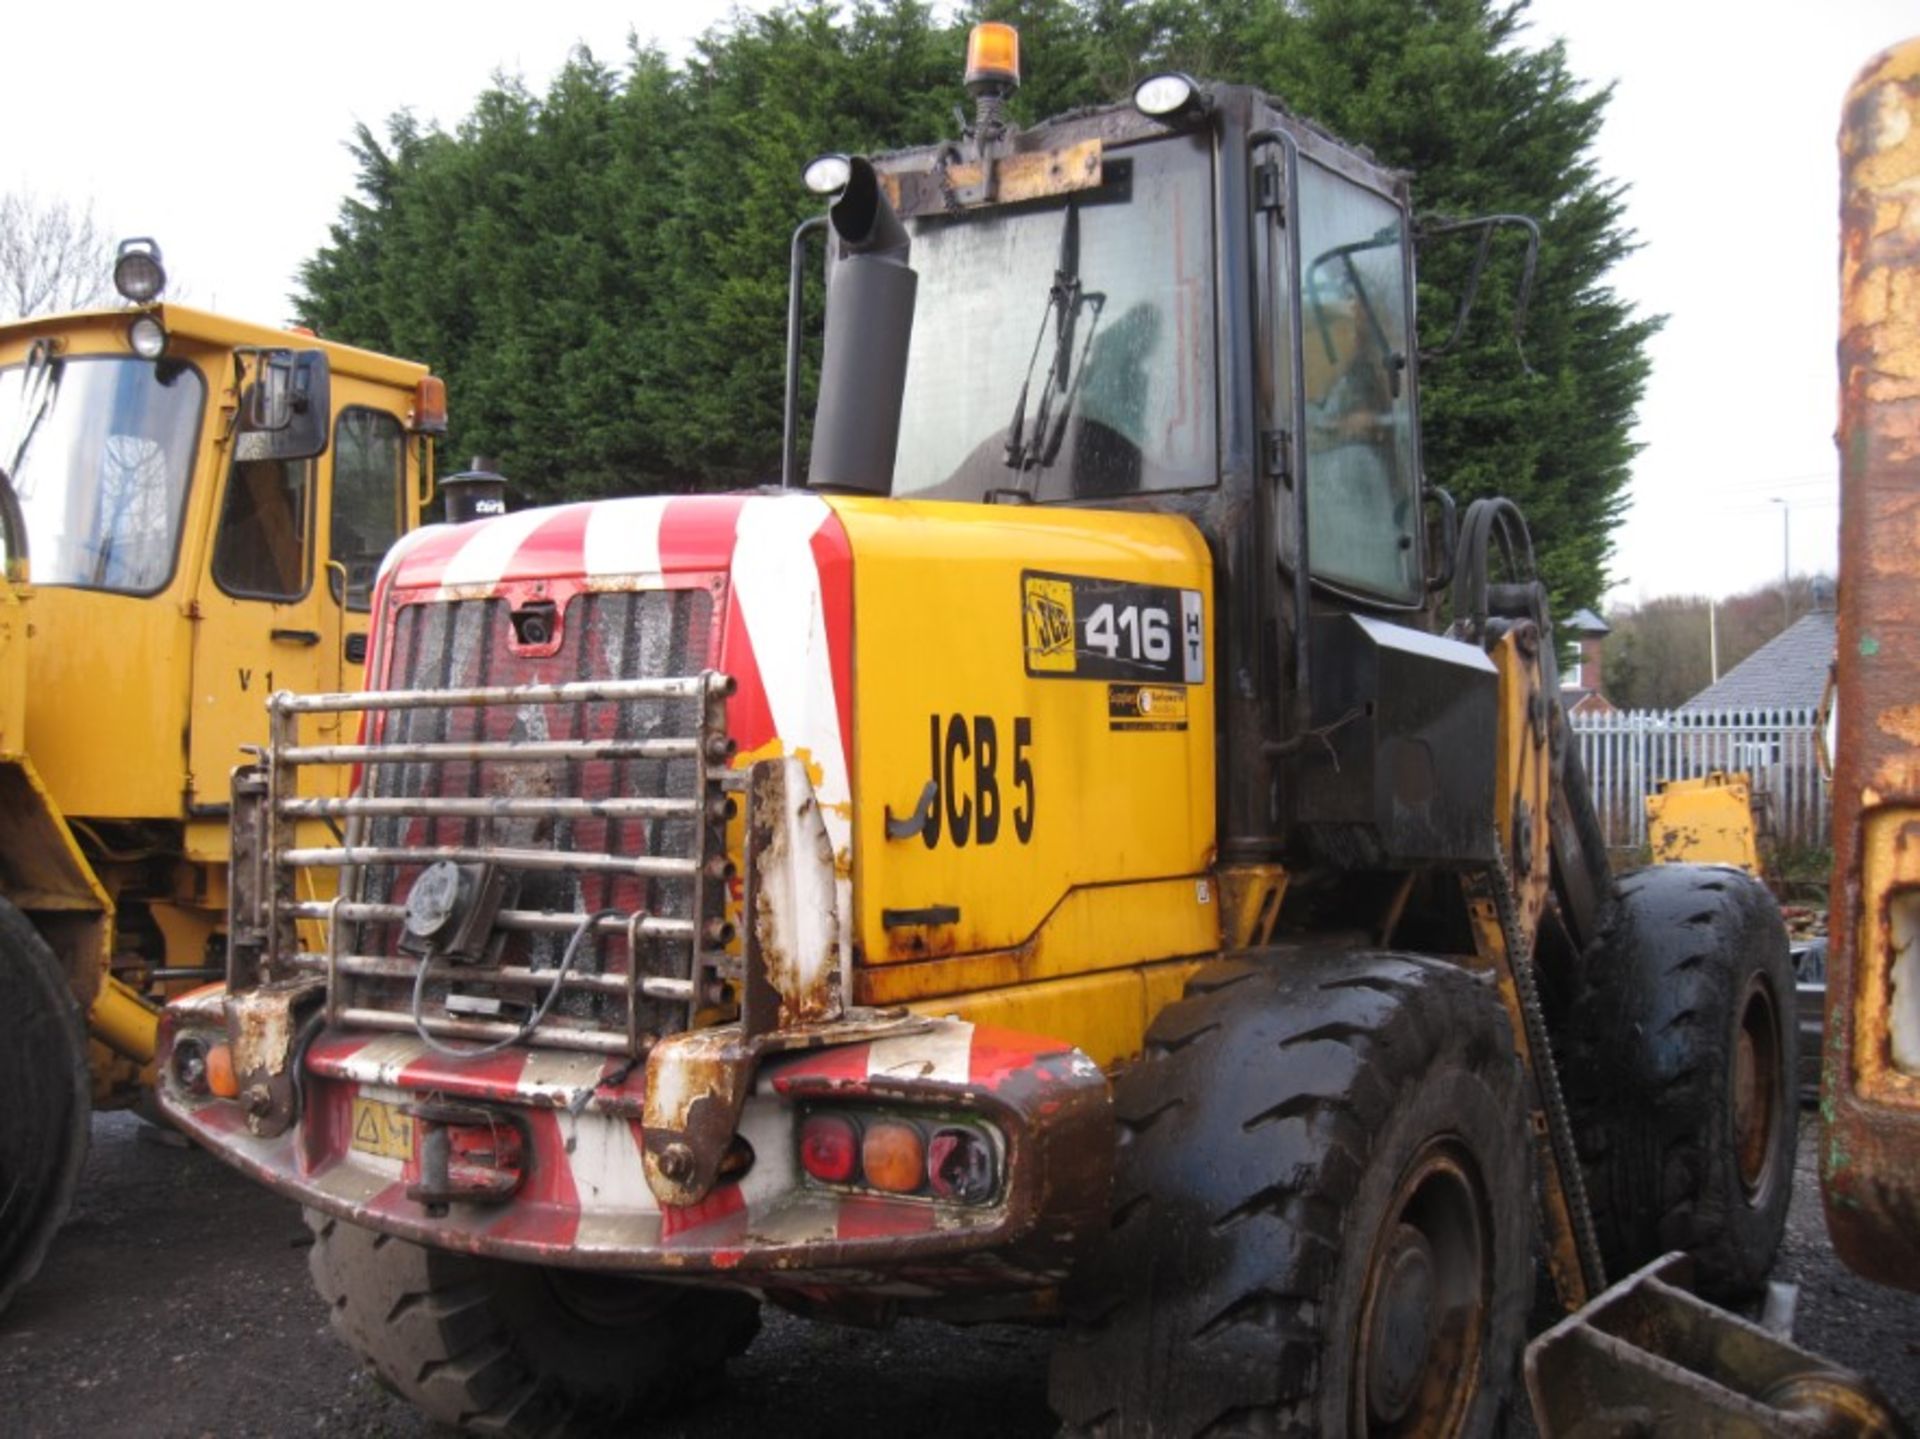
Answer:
[1050,953,1532,1439]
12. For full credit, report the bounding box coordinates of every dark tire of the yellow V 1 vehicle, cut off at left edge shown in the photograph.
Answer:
[0,899,90,1312]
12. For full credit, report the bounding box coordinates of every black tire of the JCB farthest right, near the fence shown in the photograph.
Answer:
[1563,865,1799,1299]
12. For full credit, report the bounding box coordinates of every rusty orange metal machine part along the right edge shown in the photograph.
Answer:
[1820,40,1920,1289]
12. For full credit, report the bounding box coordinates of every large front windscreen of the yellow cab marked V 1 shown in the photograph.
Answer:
[0,355,205,594]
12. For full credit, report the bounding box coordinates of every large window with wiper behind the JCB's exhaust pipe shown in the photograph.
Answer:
[893,136,1217,500]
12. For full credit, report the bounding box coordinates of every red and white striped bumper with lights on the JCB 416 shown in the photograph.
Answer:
[159,995,1114,1295]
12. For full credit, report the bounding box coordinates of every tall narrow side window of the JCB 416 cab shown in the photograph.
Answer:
[1300,159,1421,601]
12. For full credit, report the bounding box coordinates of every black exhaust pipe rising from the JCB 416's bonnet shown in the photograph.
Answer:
[806,159,920,494]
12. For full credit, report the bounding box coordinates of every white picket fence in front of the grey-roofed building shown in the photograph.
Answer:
[1572,707,1830,849]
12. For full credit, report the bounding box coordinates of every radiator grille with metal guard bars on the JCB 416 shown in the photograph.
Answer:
[234,588,732,1055]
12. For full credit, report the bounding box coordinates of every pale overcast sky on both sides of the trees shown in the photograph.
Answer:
[0,0,1920,599]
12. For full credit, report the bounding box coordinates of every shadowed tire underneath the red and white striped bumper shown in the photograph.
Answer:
[307,1210,760,1435]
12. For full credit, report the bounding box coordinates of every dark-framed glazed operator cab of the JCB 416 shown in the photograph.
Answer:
[794,40,1425,609]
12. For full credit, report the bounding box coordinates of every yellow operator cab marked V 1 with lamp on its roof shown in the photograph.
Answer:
[0,240,445,826]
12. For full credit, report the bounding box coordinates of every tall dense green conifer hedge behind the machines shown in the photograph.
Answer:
[294,0,1657,613]
